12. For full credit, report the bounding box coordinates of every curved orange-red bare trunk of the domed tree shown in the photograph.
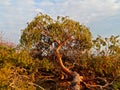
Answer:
[56,43,83,90]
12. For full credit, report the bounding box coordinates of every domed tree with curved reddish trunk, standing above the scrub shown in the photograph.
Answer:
[20,13,92,90]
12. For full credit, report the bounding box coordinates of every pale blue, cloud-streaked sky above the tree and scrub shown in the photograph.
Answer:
[0,0,120,44]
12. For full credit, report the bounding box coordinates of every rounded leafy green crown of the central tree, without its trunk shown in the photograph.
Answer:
[20,13,92,55]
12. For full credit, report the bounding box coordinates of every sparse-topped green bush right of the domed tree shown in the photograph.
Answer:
[90,36,120,77]
